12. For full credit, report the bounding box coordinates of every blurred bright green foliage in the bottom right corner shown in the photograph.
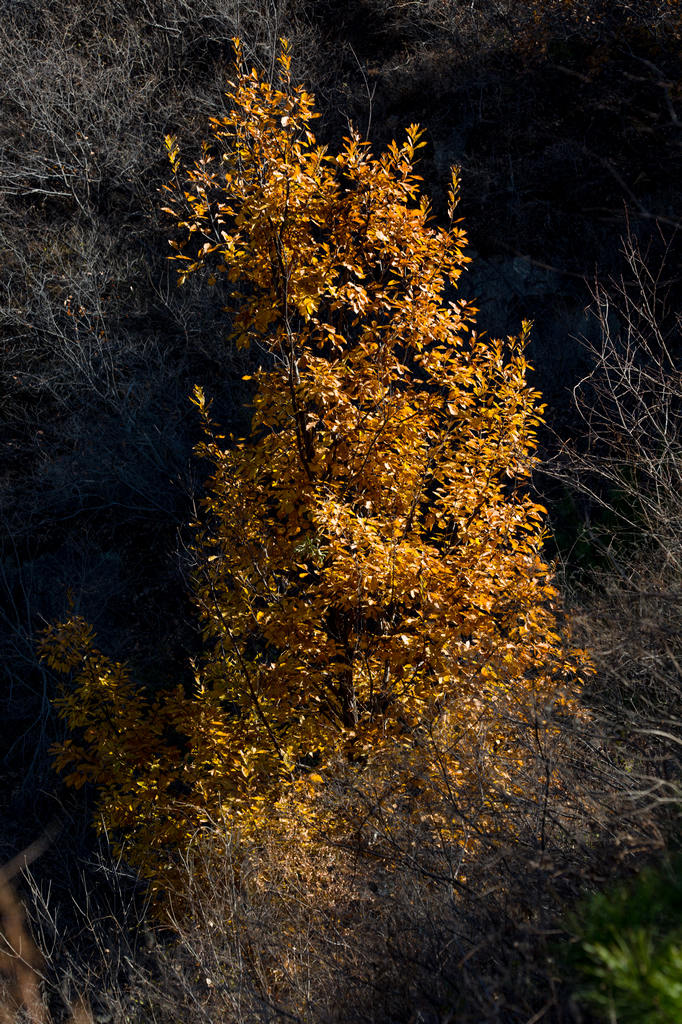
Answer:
[569,857,682,1024]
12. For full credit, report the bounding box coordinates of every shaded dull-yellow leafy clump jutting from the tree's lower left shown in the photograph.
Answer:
[40,615,278,888]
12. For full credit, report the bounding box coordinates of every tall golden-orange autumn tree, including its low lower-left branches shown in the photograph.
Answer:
[43,39,580,880]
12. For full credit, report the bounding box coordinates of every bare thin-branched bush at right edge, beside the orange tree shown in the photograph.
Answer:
[571,230,682,571]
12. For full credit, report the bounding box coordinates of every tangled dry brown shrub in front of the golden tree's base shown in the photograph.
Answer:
[122,700,655,1024]
